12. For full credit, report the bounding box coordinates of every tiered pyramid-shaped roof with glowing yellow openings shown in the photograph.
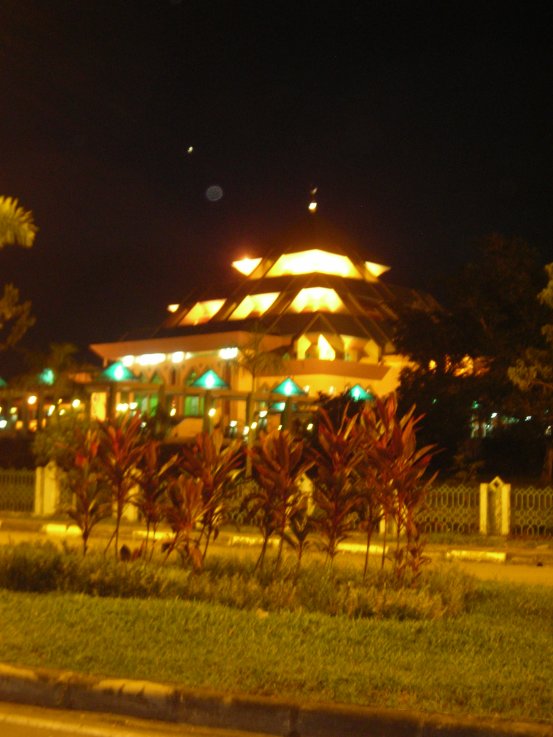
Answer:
[122,234,434,352]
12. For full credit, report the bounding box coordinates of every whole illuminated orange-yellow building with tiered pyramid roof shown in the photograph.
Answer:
[91,247,434,432]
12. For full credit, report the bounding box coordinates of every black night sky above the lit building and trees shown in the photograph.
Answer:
[0,0,553,356]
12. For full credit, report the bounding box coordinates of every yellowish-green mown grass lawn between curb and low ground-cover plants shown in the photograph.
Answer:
[0,583,553,722]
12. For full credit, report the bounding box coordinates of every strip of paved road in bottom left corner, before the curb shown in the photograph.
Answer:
[0,702,268,737]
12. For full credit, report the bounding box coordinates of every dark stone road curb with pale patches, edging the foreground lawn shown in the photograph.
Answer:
[0,664,553,737]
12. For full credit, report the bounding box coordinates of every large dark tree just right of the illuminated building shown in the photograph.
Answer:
[395,235,543,470]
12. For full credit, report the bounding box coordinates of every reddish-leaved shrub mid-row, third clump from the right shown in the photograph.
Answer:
[245,430,313,568]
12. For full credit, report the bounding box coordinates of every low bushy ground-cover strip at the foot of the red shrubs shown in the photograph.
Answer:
[0,540,475,620]
